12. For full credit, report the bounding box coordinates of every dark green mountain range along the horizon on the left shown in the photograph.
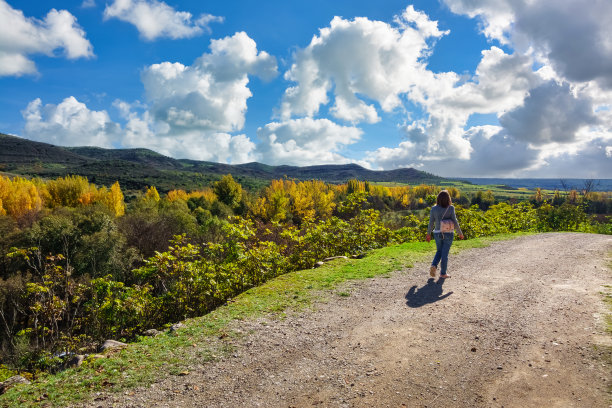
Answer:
[0,133,445,191]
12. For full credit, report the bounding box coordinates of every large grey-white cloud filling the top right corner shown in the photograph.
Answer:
[443,0,612,88]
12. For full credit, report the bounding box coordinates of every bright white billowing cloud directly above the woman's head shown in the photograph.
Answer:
[368,47,541,169]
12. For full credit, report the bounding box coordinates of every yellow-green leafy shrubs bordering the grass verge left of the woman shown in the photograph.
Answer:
[0,199,391,368]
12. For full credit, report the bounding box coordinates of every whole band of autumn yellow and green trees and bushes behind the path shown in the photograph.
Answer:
[0,176,611,376]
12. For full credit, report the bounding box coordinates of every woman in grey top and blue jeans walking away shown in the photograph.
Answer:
[426,190,463,279]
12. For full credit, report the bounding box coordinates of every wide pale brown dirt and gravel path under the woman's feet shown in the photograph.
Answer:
[92,234,612,408]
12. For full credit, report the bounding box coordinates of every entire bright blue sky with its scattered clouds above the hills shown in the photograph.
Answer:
[0,0,612,178]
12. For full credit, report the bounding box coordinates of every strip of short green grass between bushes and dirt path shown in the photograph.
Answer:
[0,234,525,407]
